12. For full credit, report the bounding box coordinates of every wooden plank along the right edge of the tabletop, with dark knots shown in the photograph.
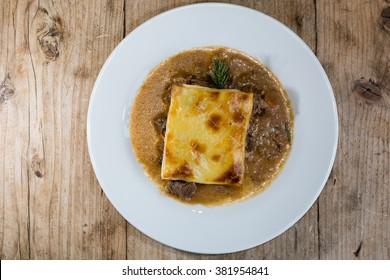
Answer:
[317,0,390,259]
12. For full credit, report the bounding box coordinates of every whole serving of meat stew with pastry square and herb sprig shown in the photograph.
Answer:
[130,47,294,206]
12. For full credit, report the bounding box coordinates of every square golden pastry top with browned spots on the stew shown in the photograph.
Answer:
[161,85,253,185]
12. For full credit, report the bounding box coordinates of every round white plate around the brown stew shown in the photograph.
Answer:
[88,3,338,253]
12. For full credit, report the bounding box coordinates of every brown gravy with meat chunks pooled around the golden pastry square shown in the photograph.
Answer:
[130,47,294,206]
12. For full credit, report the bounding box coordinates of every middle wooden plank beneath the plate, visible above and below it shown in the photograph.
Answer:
[125,0,319,259]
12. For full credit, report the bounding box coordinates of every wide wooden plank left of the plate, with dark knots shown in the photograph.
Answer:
[0,1,126,259]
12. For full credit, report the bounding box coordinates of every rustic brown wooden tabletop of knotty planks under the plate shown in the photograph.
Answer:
[0,0,390,259]
